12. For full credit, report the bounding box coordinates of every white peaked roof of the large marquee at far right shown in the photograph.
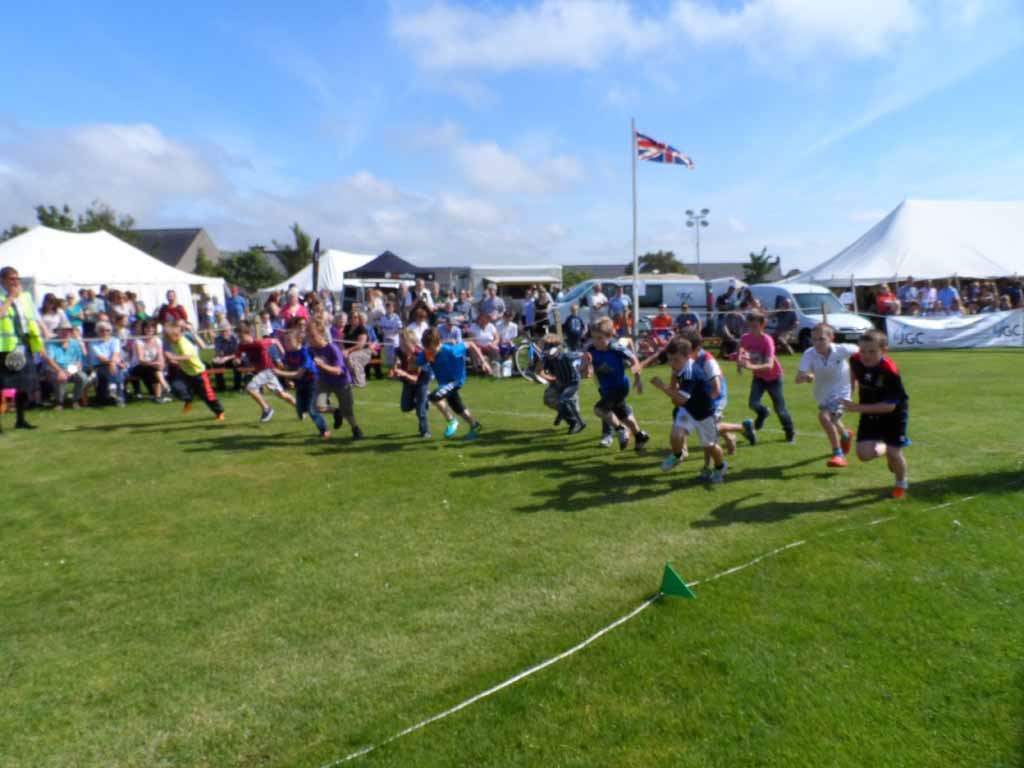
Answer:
[793,200,1024,287]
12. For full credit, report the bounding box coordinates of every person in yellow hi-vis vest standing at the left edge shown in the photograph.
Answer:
[0,266,49,429]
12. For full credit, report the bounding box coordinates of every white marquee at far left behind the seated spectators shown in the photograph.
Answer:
[0,226,224,322]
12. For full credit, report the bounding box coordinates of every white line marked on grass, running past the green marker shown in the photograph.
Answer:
[323,489,995,768]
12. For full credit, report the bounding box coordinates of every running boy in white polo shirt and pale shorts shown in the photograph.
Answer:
[797,323,857,467]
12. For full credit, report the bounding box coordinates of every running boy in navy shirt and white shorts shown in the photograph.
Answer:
[650,338,727,484]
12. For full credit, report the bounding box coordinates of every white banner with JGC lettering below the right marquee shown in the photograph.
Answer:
[886,309,1024,349]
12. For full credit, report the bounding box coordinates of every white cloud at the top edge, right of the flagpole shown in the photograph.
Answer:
[672,0,921,58]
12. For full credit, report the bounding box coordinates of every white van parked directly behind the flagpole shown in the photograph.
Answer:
[555,274,708,322]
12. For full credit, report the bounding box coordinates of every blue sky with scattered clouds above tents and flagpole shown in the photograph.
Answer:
[0,0,1024,268]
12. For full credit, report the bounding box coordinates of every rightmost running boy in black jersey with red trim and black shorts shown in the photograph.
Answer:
[843,331,909,499]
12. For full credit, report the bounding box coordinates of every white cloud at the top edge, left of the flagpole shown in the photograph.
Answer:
[391,0,665,72]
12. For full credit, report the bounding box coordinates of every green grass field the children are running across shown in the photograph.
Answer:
[0,352,1024,768]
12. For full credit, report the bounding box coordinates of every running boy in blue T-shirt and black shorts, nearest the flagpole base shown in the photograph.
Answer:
[583,317,650,454]
